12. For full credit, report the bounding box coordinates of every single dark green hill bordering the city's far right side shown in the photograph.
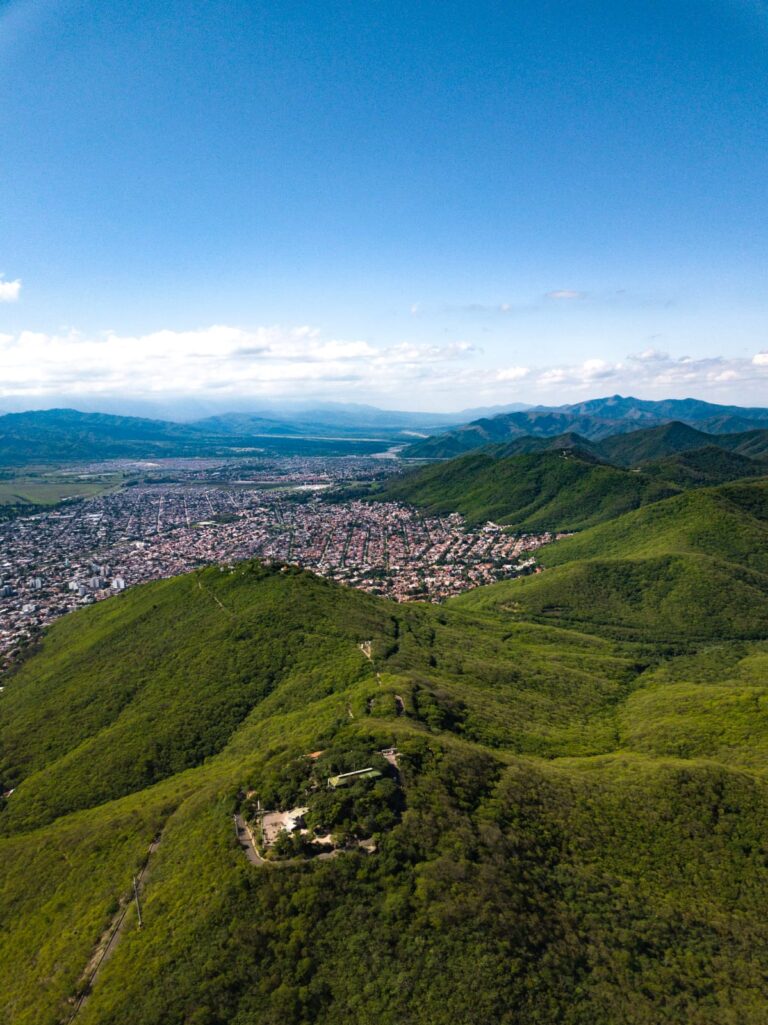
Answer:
[380,449,677,530]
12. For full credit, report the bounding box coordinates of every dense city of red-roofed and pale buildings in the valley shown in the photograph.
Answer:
[0,457,553,667]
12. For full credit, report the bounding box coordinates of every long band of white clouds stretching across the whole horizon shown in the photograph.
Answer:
[0,325,768,411]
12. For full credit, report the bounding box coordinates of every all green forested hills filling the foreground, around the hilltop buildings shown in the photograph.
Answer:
[0,541,768,1025]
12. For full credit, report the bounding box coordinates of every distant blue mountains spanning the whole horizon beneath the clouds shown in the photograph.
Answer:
[0,396,768,466]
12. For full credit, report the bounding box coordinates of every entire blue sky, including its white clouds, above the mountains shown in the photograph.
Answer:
[0,0,768,409]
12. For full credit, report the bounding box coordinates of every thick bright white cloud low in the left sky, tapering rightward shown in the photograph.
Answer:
[0,324,475,397]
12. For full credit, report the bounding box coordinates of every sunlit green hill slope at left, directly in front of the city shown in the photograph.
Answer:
[0,566,385,831]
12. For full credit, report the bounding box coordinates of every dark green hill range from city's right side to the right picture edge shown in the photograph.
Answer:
[383,422,768,531]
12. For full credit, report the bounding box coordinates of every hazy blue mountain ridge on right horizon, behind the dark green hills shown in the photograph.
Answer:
[402,395,768,459]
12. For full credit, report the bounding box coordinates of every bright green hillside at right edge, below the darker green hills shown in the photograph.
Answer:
[457,481,768,641]
